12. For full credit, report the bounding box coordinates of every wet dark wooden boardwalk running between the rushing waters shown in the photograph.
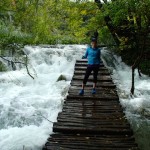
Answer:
[43,60,138,150]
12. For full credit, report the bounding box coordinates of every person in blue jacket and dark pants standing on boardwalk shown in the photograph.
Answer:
[79,37,101,95]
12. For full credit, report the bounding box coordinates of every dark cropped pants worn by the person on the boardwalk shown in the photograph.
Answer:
[83,65,99,84]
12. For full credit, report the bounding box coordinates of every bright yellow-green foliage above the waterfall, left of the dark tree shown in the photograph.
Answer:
[0,0,103,45]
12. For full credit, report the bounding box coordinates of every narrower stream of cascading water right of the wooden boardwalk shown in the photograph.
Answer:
[102,49,150,150]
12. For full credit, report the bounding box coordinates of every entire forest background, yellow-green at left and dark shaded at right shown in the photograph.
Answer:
[0,0,150,74]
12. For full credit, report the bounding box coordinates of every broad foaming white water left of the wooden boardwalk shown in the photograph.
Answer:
[0,45,86,150]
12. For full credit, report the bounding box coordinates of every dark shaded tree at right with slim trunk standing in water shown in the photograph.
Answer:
[95,0,150,94]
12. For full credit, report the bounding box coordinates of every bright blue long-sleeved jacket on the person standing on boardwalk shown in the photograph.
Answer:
[83,47,101,65]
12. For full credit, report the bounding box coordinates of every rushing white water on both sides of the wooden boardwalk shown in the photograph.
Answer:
[0,45,150,150]
